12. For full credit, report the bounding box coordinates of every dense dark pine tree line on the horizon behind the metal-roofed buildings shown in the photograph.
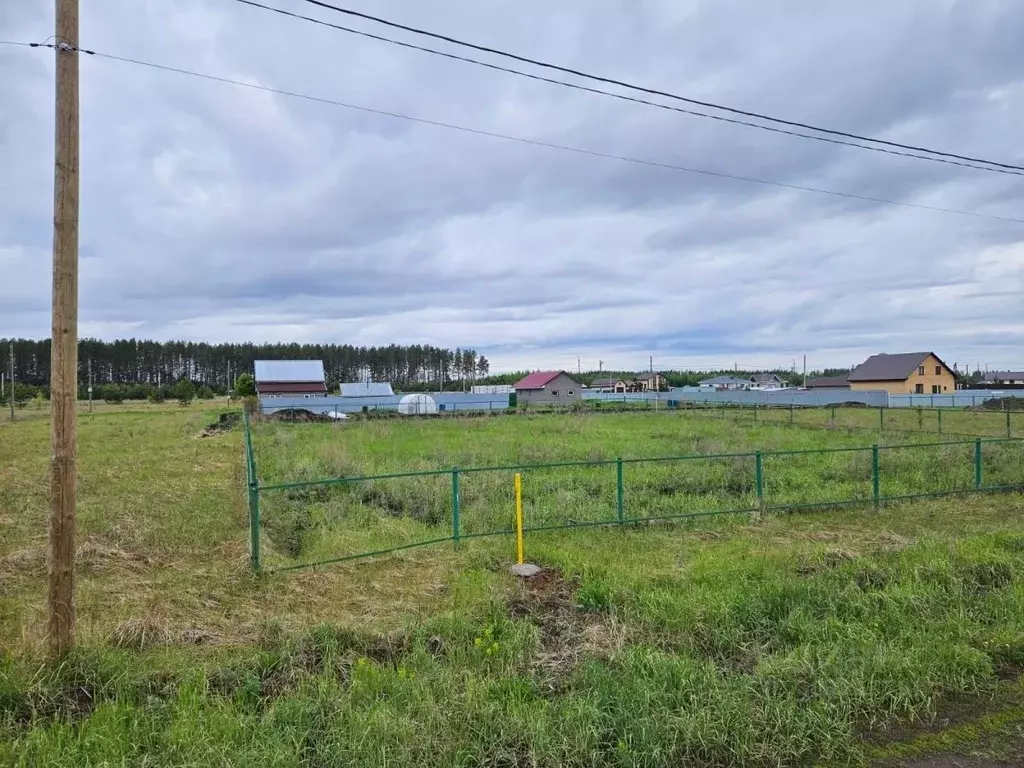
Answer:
[0,339,490,401]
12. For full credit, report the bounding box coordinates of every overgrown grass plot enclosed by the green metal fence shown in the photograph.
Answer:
[247,410,1024,567]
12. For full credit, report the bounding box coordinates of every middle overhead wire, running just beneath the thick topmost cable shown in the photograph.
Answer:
[222,0,1024,176]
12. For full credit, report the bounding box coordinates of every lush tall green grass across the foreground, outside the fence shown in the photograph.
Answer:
[6,527,1024,766]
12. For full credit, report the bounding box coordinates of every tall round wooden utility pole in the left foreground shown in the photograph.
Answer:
[47,0,79,656]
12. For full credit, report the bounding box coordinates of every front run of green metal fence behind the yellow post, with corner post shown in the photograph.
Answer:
[245,416,1024,572]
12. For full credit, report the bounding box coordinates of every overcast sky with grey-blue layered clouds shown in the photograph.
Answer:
[0,0,1024,370]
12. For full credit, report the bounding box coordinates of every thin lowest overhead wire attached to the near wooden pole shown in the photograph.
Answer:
[8,43,1024,224]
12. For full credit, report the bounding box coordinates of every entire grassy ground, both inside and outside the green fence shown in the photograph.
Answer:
[0,406,1024,766]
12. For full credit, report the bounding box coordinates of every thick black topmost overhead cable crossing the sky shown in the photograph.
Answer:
[288,0,1024,171]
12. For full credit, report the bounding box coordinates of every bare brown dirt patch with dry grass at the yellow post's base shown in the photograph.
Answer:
[508,568,625,691]
